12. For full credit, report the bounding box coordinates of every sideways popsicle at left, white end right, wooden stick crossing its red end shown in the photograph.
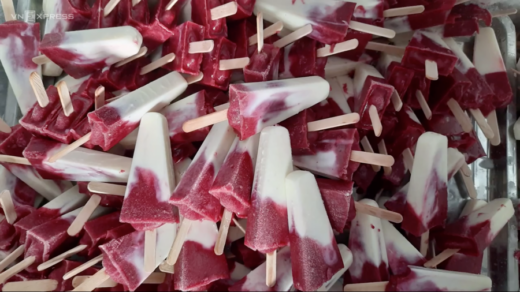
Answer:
[23,137,132,182]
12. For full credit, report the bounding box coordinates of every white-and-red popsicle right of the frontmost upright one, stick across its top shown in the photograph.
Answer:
[346,199,389,283]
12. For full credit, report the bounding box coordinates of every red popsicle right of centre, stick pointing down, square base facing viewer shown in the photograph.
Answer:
[354,64,395,137]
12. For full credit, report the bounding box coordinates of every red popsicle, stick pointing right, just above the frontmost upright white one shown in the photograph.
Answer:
[293,129,394,181]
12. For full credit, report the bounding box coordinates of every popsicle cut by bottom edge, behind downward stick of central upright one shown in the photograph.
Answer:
[229,247,293,291]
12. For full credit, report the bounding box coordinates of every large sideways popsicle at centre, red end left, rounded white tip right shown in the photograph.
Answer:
[227,76,329,140]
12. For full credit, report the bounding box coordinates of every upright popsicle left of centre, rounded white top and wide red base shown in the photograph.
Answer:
[120,113,179,230]
